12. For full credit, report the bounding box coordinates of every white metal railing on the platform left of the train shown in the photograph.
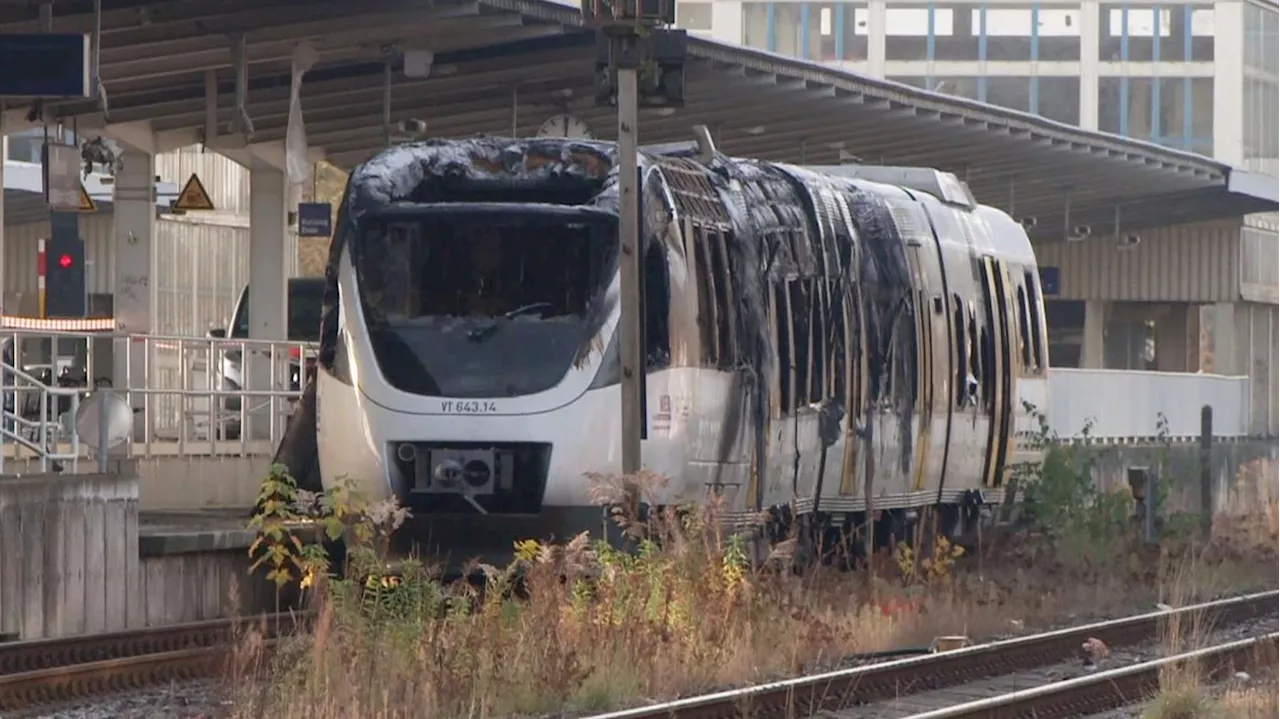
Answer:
[0,330,316,460]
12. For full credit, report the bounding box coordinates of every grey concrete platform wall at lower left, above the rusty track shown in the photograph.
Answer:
[0,472,273,640]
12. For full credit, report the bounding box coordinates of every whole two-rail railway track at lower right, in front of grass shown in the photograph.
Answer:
[590,591,1280,719]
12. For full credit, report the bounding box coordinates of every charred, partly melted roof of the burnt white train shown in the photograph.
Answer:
[339,137,1033,266]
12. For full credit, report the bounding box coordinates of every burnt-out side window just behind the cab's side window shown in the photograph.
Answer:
[692,226,737,368]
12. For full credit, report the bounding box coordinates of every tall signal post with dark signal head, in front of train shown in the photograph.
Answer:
[581,0,687,478]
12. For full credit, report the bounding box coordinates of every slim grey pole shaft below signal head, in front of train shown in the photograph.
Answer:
[614,51,645,475]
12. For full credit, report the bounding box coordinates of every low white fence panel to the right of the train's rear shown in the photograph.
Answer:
[1047,367,1249,441]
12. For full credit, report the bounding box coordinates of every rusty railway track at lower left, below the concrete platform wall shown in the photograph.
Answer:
[0,613,310,713]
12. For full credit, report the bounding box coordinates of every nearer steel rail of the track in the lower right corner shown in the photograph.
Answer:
[906,632,1280,719]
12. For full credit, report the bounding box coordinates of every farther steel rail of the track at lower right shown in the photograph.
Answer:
[589,591,1280,719]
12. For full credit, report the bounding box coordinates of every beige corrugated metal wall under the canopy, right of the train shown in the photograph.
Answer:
[1036,221,1239,302]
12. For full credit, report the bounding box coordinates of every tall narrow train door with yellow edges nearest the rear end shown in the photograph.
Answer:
[980,256,1018,486]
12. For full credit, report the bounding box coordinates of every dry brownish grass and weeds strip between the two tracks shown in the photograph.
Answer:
[228,468,1280,719]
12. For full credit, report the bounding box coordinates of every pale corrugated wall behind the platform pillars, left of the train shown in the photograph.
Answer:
[4,215,248,335]
